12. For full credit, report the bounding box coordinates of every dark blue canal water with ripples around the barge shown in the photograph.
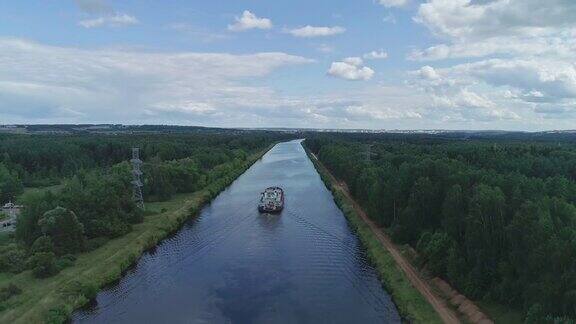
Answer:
[73,141,400,323]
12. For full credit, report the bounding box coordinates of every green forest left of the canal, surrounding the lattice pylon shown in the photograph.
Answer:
[0,133,283,277]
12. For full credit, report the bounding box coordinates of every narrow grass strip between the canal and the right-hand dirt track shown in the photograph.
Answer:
[310,149,442,323]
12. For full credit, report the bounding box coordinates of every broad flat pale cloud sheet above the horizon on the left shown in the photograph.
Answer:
[0,38,312,124]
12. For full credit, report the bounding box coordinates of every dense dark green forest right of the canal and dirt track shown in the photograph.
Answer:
[305,135,576,323]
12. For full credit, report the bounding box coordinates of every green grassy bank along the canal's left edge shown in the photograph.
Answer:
[0,149,268,323]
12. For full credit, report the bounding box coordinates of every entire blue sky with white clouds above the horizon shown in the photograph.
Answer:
[0,0,576,130]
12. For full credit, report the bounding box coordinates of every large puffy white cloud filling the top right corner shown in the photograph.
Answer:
[410,0,576,60]
